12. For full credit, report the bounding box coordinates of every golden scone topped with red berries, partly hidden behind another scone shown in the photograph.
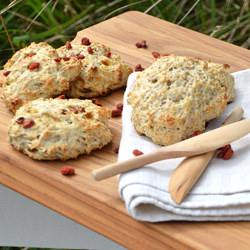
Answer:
[57,42,132,98]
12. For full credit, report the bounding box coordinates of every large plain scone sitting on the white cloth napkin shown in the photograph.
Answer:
[127,55,234,145]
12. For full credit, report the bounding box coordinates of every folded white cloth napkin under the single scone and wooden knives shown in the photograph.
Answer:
[118,69,250,222]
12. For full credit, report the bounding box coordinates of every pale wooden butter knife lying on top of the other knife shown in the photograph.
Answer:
[92,116,250,180]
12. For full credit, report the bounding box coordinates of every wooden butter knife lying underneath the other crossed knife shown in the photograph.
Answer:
[169,107,244,204]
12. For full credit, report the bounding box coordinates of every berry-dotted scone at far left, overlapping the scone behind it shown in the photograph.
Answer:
[2,43,81,112]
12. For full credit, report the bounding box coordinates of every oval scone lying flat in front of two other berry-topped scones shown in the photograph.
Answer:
[8,98,113,160]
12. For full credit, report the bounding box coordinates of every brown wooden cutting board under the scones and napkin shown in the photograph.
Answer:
[0,11,250,249]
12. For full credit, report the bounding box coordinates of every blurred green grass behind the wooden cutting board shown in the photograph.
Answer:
[0,0,250,68]
